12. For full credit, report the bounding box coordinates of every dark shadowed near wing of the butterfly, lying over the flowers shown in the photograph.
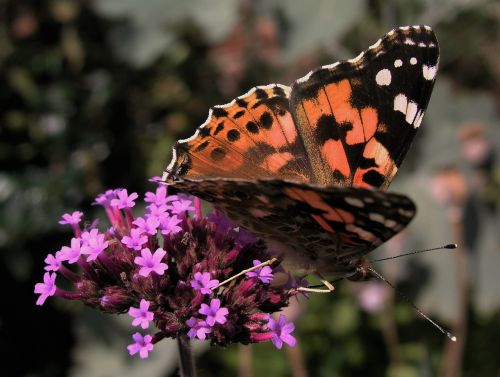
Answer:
[176,178,416,275]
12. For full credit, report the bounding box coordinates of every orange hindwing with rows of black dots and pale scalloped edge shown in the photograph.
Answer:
[166,84,311,181]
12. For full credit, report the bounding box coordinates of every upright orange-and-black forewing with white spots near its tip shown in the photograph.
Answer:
[290,26,439,189]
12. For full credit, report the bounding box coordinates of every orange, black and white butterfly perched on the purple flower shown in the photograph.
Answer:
[163,26,439,280]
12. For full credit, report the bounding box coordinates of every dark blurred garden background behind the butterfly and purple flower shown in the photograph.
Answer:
[0,0,500,377]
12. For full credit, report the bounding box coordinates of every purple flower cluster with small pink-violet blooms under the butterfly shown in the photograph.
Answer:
[35,180,297,358]
